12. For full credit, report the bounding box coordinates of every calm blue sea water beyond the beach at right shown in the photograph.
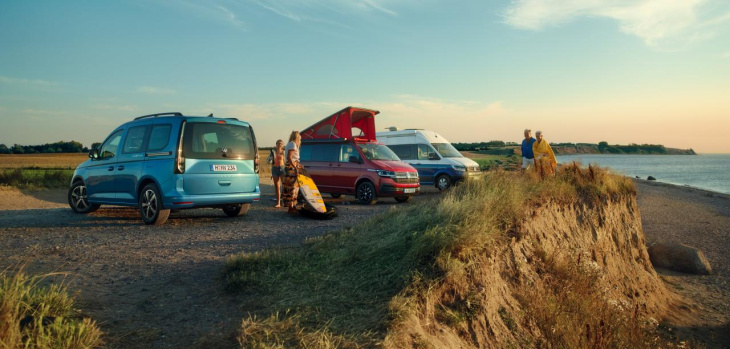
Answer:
[557,154,730,194]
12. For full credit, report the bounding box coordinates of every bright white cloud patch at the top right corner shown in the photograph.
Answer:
[503,0,730,49]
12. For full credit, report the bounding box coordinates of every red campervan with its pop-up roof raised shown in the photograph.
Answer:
[300,107,421,204]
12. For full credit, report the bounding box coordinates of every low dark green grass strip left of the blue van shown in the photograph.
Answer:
[0,168,74,189]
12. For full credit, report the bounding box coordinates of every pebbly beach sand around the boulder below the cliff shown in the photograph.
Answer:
[636,180,730,348]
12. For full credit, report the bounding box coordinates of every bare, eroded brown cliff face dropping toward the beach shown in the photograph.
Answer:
[385,195,676,348]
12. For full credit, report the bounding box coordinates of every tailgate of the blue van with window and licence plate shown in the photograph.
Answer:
[182,119,258,195]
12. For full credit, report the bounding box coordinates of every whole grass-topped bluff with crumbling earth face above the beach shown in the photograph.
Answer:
[225,166,676,348]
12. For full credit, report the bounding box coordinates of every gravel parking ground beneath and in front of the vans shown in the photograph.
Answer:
[0,181,439,348]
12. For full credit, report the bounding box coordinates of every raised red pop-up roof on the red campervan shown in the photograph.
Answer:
[301,107,380,141]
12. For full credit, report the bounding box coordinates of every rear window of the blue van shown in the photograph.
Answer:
[182,122,256,159]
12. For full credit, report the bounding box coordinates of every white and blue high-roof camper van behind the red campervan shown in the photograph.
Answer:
[376,127,482,190]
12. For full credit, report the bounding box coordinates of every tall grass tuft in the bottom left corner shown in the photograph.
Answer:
[0,270,103,348]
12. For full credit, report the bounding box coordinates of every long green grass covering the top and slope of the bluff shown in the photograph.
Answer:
[224,164,635,348]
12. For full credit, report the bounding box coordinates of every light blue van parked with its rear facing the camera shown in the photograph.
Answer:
[68,112,261,225]
